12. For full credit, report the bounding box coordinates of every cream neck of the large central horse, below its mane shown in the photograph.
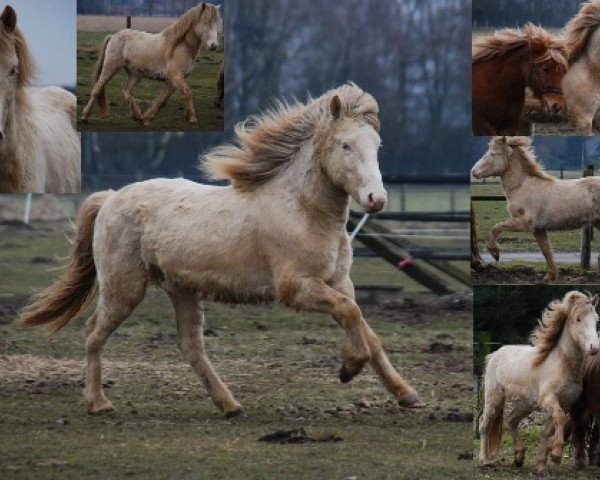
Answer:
[273,141,350,231]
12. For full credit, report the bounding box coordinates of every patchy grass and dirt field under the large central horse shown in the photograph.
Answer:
[0,210,473,480]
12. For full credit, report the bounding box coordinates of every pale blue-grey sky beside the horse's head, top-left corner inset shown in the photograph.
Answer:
[5,0,77,86]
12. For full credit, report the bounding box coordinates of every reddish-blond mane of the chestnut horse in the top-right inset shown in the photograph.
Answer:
[471,23,568,71]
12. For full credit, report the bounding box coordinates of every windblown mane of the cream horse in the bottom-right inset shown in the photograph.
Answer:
[530,290,594,367]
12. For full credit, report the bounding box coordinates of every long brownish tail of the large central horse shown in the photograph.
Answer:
[18,190,114,334]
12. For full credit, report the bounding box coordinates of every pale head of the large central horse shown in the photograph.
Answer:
[321,95,387,213]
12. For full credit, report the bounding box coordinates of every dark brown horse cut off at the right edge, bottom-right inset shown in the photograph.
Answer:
[571,357,600,468]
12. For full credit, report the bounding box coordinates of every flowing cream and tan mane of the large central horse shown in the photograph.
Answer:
[200,83,379,190]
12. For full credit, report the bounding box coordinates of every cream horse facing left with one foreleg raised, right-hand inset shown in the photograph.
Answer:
[471,137,600,282]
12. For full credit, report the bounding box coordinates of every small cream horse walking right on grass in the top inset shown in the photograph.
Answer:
[81,3,222,125]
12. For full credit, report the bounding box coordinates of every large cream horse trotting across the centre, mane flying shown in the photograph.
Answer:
[20,84,423,416]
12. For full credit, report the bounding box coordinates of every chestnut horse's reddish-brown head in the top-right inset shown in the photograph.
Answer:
[525,36,568,113]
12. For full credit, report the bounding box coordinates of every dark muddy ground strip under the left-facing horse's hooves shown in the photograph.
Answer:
[471,265,600,285]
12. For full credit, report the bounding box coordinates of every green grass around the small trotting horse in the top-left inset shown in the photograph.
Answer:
[77,31,224,131]
